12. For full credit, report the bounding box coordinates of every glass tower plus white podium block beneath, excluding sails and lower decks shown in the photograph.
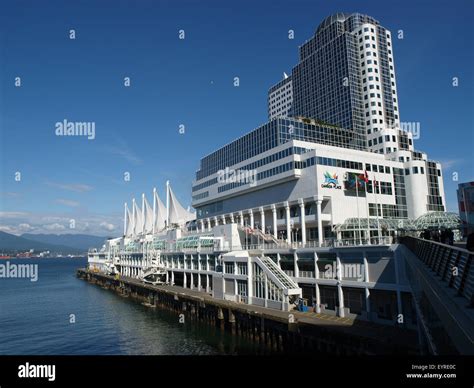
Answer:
[192,13,445,236]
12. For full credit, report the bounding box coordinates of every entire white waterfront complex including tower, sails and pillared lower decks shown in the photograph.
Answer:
[89,13,445,328]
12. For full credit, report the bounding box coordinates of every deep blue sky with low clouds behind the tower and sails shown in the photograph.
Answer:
[0,0,474,235]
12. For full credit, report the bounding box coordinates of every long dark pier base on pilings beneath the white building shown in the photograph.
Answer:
[76,269,417,355]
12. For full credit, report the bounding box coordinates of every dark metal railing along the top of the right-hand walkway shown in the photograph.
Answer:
[401,236,474,306]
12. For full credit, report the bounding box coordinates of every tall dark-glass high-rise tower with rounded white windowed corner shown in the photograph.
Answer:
[269,13,406,153]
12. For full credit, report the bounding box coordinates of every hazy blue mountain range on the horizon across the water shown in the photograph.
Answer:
[0,231,106,254]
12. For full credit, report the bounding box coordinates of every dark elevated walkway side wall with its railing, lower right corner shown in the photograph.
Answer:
[400,236,474,355]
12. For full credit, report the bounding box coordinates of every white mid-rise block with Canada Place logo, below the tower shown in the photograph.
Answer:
[193,118,444,239]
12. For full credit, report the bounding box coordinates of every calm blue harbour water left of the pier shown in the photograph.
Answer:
[0,259,254,355]
